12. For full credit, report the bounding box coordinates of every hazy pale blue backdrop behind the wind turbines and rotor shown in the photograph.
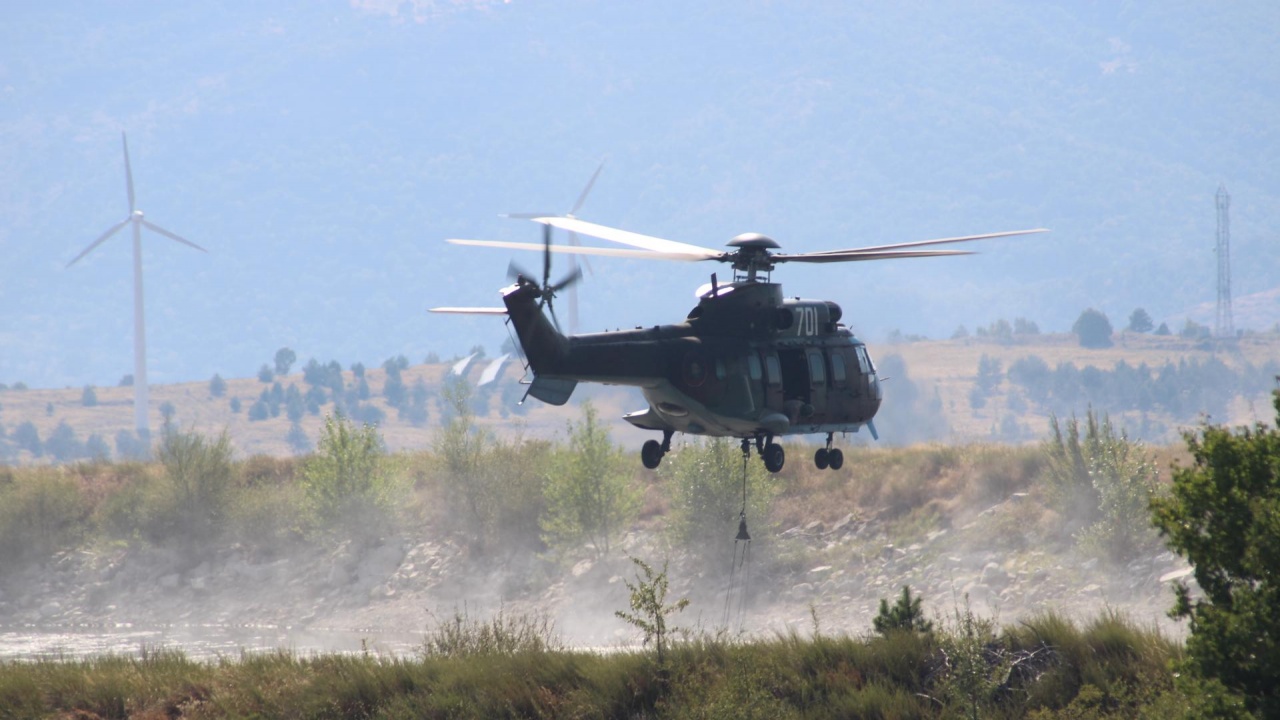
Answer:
[0,0,1280,386]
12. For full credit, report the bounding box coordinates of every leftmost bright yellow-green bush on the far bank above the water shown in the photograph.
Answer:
[302,413,401,534]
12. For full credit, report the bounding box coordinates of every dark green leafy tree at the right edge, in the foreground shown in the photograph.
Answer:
[1152,391,1280,717]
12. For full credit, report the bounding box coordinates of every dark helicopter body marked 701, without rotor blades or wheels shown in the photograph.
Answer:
[503,281,882,438]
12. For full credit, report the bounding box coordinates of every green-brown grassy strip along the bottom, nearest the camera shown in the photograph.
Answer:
[0,611,1192,719]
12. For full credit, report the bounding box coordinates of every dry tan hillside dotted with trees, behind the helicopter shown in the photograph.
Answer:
[0,333,1280,462]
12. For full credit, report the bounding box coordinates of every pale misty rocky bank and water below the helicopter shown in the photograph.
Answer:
[0,495,1190,659]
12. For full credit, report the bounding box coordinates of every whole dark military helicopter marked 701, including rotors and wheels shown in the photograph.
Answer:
[431,215,1046,473]
